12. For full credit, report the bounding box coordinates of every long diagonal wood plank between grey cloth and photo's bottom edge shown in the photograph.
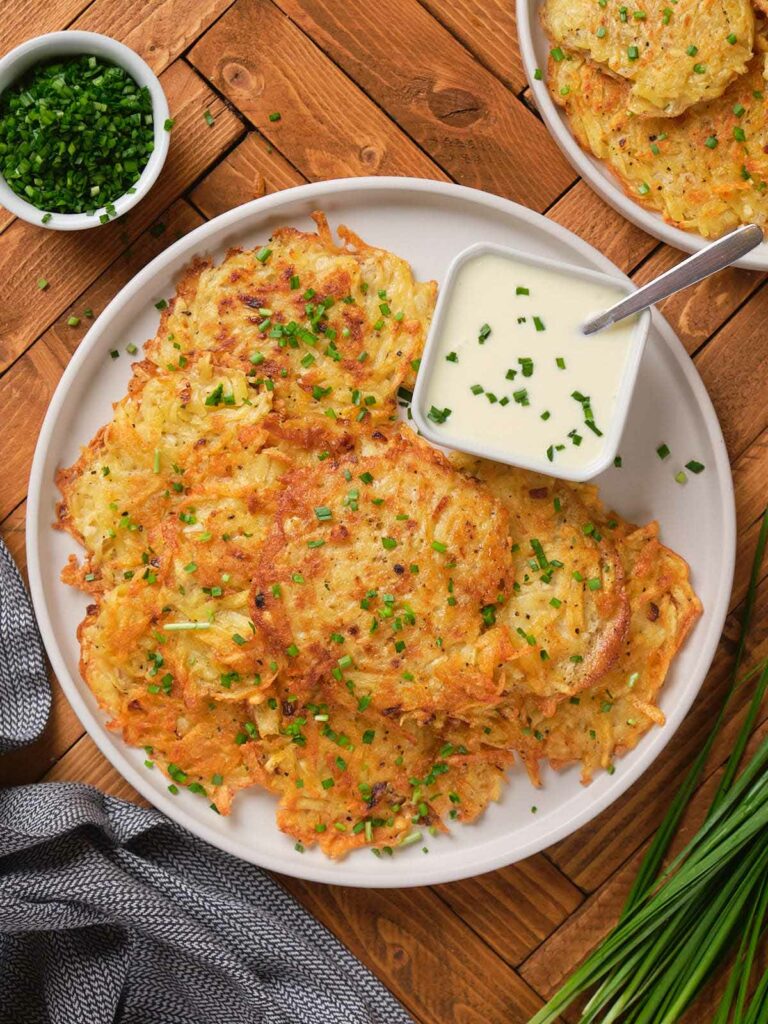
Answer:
[279,877,541,1024]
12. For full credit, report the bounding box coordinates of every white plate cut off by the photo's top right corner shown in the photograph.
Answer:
[517,0,768,270]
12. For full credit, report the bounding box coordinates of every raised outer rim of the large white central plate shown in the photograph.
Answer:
[26,177,736,888]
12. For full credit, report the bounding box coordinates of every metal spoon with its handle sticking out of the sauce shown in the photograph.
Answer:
[582,224,763,334]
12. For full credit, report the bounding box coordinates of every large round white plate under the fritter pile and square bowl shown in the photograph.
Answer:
[27,178,735,887]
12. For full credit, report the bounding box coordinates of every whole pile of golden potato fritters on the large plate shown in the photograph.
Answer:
[58,215,698,857]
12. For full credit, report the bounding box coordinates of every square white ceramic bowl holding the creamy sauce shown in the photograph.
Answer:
[411,242,650,482]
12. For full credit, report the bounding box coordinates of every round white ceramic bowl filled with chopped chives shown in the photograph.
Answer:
[0,32,170,231]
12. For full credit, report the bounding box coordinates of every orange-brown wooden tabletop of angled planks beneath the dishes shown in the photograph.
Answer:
[0,0,768,1024]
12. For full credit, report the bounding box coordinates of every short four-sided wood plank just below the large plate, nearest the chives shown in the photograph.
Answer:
[434,854,584,967]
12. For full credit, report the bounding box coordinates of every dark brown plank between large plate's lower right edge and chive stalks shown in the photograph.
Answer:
[547,579,768,892]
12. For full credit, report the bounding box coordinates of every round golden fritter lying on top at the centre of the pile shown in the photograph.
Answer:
[253,427,512,717]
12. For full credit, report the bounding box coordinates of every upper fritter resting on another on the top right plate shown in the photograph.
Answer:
[542,0,755,118]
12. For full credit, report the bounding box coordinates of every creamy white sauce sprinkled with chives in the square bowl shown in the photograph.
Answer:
[422,253,636,475]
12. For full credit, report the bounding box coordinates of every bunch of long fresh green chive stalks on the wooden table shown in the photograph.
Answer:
[529,509,768,1024]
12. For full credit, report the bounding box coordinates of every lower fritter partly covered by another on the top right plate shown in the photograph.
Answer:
[550,39,768,238]
